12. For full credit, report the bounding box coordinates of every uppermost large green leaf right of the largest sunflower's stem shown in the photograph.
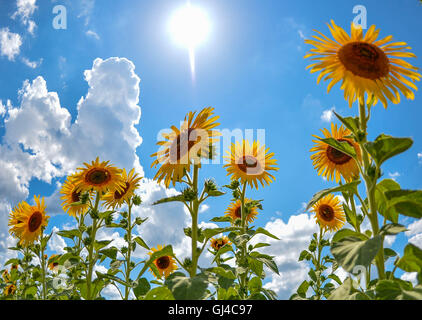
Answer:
[365,134,413,167]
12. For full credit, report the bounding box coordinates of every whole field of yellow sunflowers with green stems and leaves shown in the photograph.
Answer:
[0,21,422,300]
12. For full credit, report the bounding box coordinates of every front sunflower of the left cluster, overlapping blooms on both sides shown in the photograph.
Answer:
[72,157,125,193]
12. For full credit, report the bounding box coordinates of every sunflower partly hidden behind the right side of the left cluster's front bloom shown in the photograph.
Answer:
[103,169,142,209]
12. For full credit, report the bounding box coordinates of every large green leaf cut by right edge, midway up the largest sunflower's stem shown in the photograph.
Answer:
[385,190,422,219]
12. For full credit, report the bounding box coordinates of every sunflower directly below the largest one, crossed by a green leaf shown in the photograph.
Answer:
[310,123,361,183]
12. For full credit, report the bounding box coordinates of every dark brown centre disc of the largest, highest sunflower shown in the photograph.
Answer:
[338,42,390,80]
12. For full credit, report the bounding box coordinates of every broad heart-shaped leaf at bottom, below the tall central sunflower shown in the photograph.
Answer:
[165,272,209,300]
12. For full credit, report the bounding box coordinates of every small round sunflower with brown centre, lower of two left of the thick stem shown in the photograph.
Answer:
[311,194,346,231]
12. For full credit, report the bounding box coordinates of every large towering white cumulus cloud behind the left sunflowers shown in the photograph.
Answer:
[0,58,143,262]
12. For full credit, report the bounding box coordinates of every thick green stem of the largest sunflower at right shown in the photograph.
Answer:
[359,102,385,280]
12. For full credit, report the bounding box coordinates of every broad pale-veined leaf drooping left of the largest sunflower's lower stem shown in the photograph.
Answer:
[331,235,382,272]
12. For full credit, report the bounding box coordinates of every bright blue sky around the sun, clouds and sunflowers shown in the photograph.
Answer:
[0,0,422,295]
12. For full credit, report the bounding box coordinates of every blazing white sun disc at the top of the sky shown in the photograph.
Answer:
[169,3,210,50]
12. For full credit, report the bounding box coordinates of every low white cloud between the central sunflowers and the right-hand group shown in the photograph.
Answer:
[253,213,318,299]
